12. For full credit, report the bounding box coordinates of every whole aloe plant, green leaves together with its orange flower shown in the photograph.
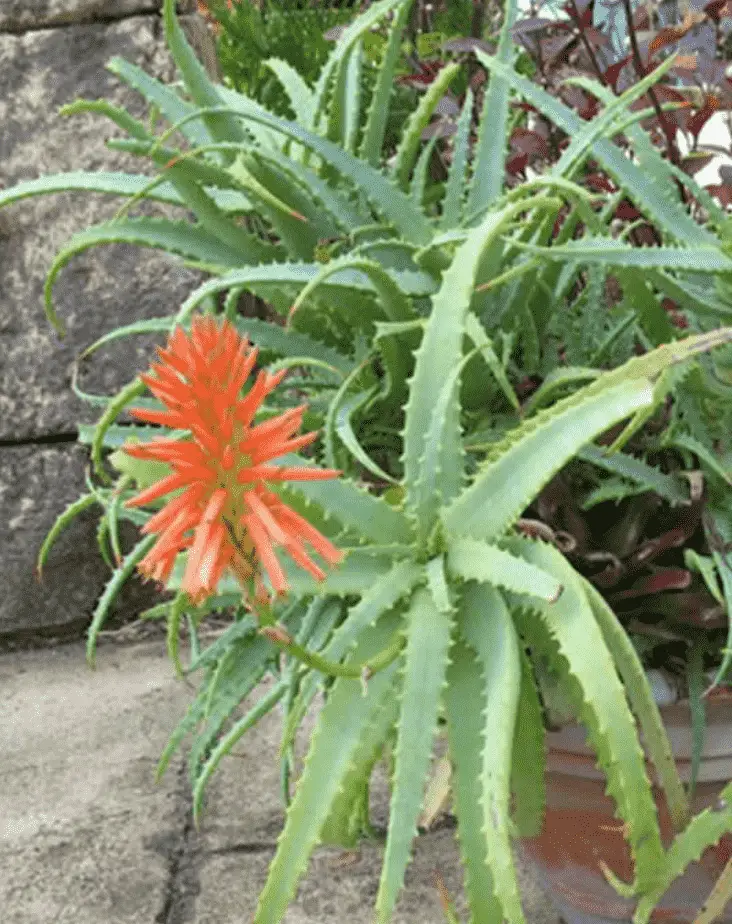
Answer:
[8,0,732,924]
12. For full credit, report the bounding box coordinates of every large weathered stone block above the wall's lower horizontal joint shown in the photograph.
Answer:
[0,16,210,441]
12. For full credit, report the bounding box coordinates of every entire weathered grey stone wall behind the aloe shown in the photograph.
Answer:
[0,0,215,642]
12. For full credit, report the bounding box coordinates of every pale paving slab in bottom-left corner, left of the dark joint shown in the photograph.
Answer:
[0,645,187,924]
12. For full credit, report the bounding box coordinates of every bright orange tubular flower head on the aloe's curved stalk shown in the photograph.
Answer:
[125,317,342,603]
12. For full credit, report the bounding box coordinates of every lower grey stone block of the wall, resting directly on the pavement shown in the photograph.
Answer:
[0,443,162,642]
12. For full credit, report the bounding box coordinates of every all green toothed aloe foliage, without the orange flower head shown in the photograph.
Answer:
[10,0,732,924]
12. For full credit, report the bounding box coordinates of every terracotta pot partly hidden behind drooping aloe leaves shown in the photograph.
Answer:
[522,699,732,924]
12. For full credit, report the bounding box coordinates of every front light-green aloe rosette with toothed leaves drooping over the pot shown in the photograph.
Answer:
[157,251,732,924]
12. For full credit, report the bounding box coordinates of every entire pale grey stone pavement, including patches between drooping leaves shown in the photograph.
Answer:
[0,640,558,924]
